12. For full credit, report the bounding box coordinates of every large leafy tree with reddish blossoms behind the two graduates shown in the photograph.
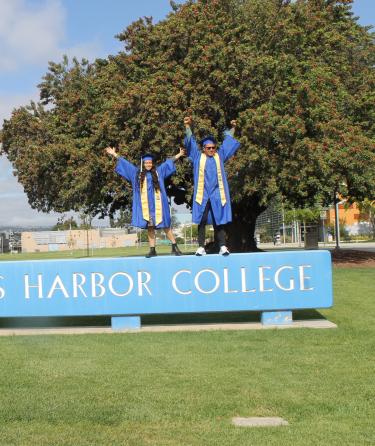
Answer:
[2,0,375,250]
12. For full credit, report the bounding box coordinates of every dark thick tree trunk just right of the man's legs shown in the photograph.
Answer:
[227,200,265,252]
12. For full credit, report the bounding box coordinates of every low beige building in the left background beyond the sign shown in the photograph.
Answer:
[21,228,137,252]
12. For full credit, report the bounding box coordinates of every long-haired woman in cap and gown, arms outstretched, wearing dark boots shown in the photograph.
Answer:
[105,147,185,258]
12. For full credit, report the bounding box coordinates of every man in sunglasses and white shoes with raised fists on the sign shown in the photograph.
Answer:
[184,116,240,256]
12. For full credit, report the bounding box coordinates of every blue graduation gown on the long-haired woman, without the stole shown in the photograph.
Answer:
[115,157,176,229]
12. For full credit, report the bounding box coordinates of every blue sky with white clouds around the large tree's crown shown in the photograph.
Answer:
[0,0,375,227]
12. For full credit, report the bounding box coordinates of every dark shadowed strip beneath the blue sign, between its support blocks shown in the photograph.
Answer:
[0,310,325,329]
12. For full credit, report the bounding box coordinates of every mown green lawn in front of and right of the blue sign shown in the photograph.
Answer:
[0,268,375,446]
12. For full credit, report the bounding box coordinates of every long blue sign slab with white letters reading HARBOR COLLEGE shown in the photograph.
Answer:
[0,251,332,328]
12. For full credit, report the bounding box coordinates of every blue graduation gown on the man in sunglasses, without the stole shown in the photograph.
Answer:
[185,132,240,225]
